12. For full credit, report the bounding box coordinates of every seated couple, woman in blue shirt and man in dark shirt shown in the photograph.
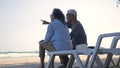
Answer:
[39,8,87,68]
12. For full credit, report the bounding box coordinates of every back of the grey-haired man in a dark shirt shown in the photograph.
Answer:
[70,21,87,45]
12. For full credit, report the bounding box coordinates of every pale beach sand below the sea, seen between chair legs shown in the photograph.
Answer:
[0,55,118,68]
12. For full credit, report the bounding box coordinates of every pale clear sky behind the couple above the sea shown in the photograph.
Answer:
[0,0,120,52]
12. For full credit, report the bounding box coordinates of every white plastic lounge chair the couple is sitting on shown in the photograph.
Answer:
[46,32,120,68]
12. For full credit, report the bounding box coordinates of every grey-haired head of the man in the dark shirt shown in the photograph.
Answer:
[66,9,77,22]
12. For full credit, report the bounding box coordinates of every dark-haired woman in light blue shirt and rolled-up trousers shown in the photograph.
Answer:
[39,8,73,68]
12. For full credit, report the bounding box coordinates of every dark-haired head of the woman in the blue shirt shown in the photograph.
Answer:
[51,8,65,25]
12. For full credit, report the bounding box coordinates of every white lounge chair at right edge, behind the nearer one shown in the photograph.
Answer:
[98,36,120,68]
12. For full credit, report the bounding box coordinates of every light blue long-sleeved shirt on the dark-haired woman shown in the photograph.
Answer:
[45,19,73,50]
